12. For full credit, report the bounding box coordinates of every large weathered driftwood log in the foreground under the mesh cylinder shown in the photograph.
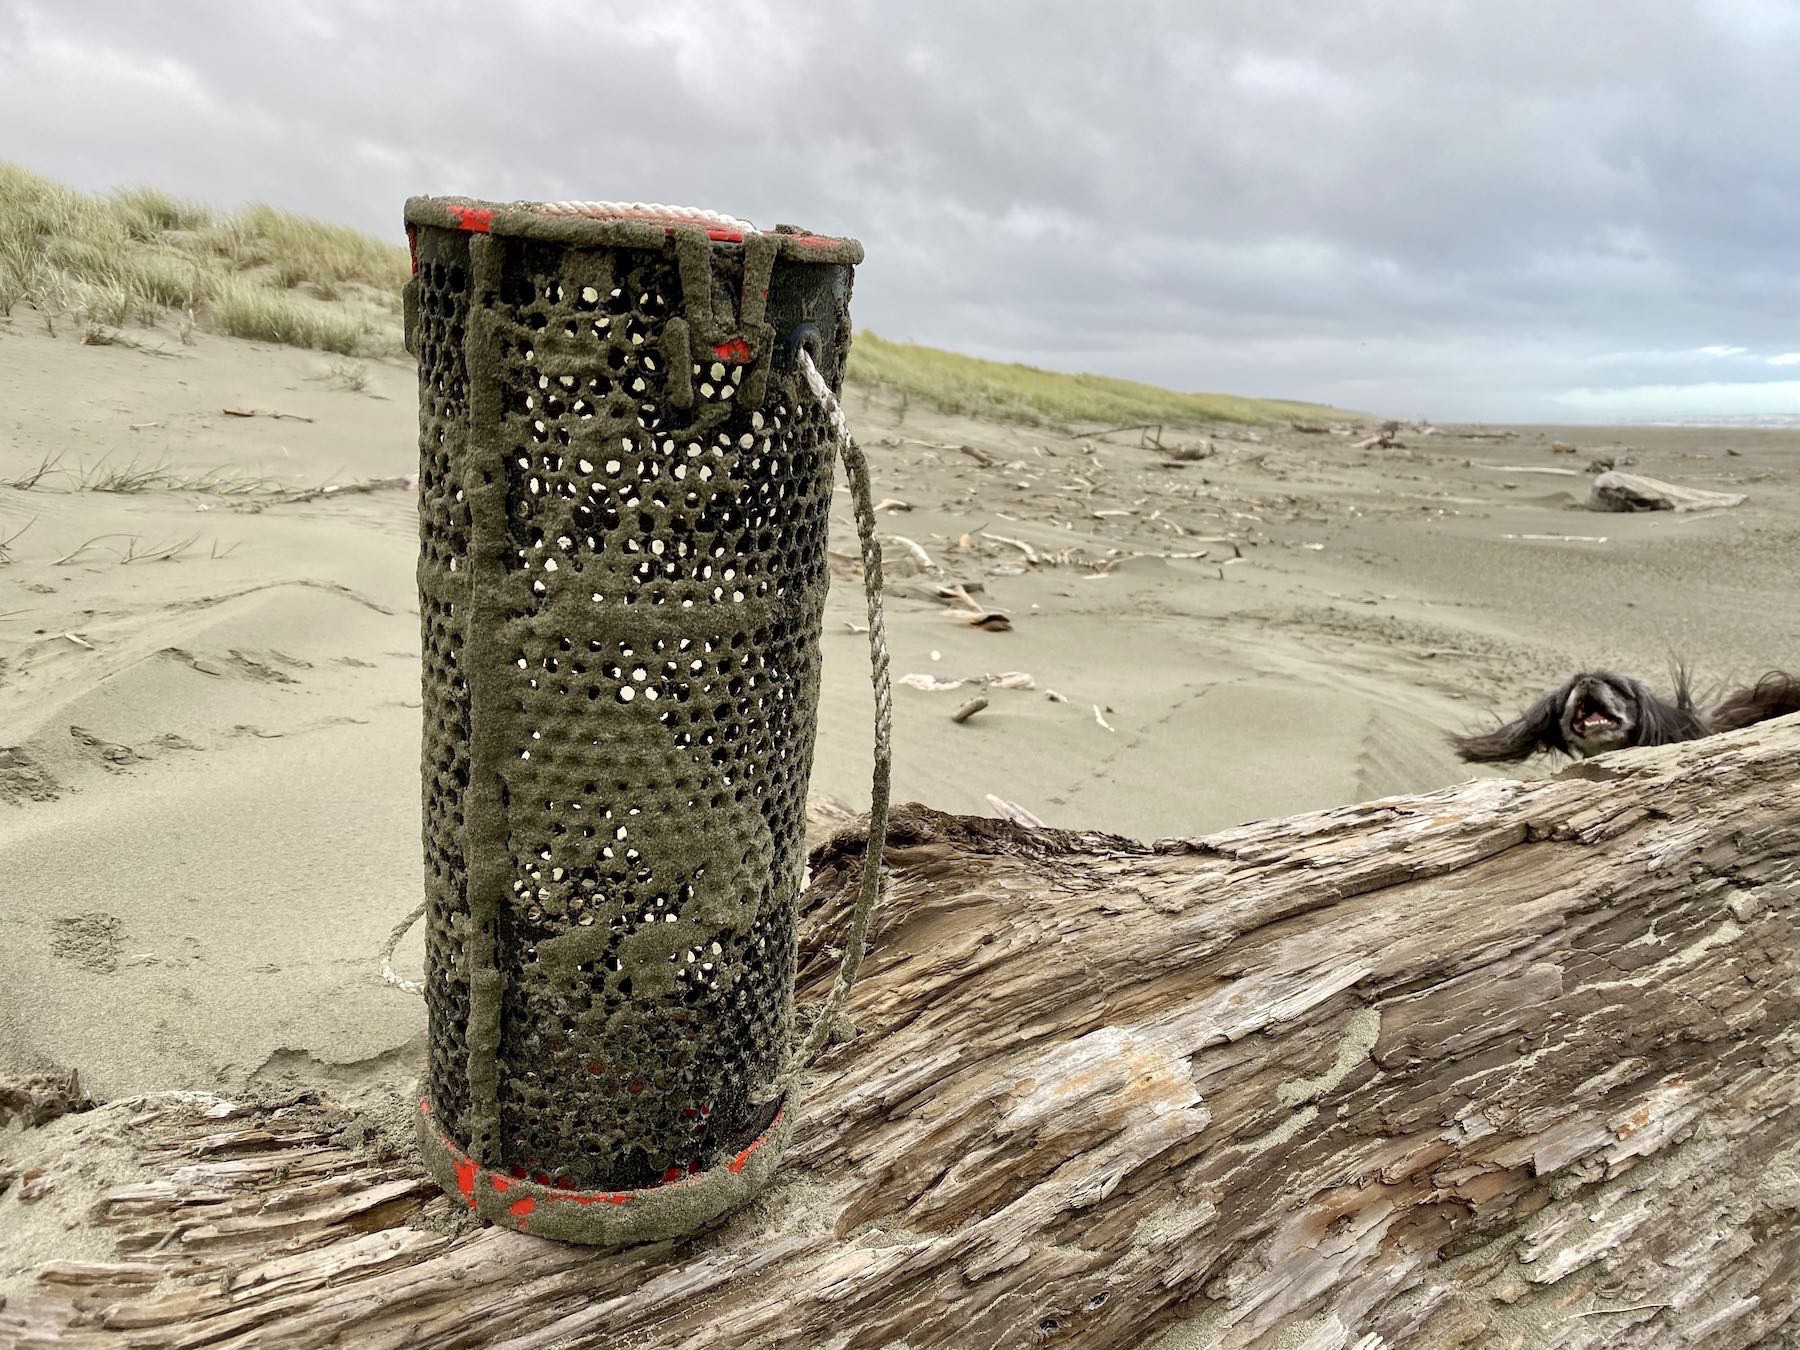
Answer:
[0,718,1800,1350]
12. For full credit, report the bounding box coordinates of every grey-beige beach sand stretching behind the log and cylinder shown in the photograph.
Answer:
[0,322,1800,1123]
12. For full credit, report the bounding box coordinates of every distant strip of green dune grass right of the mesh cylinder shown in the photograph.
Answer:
[850,329,1355,427]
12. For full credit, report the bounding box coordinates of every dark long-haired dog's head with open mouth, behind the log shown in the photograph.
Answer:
[1451,670,1706,763]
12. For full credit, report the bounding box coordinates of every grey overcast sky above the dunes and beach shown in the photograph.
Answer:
[0,0,1800,419]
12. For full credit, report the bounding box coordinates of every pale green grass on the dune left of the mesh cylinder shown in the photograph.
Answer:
[0,160,409,355]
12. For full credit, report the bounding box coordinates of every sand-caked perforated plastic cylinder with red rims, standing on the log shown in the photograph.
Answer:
[407,198,862,1242]
